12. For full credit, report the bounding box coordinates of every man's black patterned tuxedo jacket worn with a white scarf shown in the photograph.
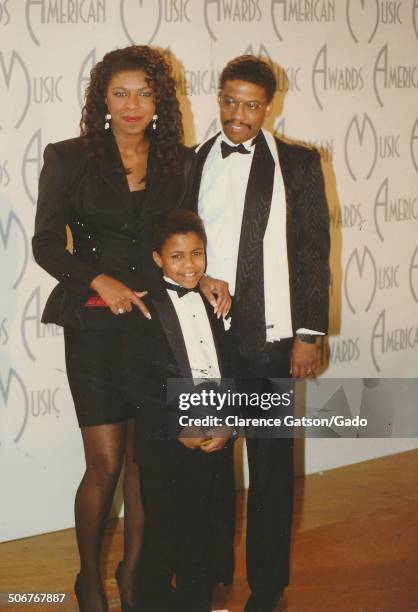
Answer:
[191,132,330,333]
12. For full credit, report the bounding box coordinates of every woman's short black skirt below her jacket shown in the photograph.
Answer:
[64,327,134,427]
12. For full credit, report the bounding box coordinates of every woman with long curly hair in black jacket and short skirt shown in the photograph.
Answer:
[33,46,228,612]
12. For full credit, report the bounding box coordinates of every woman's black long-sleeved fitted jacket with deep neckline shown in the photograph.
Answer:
[32,130,195,329]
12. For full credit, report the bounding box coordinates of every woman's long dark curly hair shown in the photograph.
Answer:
[80,45,183,182]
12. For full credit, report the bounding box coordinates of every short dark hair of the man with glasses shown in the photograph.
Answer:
[219,55,277,102]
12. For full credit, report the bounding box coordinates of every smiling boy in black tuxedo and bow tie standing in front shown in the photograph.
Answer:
[126,210,238,612]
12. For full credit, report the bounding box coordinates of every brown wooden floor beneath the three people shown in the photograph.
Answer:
[0,451,418,612]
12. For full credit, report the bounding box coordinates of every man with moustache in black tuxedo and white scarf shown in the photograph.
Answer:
[190,55,329,612]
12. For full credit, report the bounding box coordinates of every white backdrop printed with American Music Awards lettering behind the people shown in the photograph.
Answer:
[0,0,418,540]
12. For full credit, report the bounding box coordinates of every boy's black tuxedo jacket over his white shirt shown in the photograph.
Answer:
[126,287,239,463]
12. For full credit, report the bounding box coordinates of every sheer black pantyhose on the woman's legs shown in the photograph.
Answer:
[75,422,144,612]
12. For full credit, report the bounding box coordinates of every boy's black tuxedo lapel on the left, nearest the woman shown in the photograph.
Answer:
[152,291,192,378]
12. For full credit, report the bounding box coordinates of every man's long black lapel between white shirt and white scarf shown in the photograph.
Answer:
[234,133,280,354]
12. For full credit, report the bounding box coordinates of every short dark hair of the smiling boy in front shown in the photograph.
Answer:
[152,210,207,253]
